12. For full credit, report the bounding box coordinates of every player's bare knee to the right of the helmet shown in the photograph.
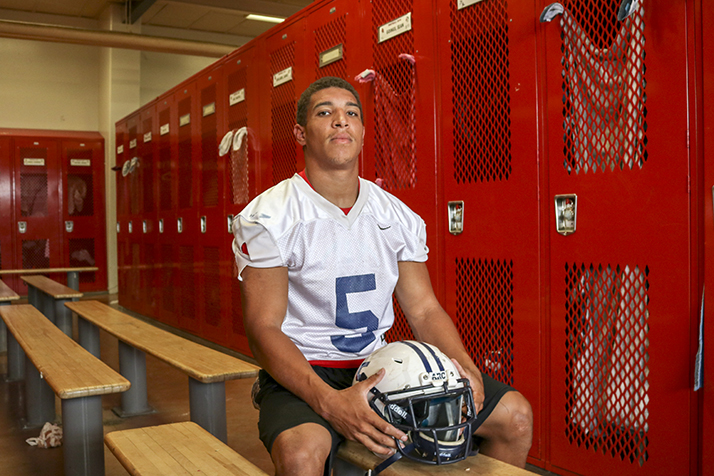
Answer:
[475,391,533,468]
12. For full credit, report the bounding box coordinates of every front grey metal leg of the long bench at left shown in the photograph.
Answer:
[62,395,104,476]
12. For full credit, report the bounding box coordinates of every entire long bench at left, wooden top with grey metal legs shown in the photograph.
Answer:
[0,304,131,476]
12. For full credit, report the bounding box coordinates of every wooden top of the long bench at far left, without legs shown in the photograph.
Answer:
[0,304,130,399]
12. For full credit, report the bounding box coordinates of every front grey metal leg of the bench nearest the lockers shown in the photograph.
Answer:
[188,377,228,443]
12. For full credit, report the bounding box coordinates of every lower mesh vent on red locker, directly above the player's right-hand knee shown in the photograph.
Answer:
[456,258,513,385]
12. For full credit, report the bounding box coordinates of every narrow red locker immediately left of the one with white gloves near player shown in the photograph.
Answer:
[196,62,231,345]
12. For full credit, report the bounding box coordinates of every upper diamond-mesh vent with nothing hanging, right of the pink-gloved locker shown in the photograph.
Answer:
[451,0,511,183]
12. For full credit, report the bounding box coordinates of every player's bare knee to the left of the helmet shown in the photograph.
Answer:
[270,423,332,476]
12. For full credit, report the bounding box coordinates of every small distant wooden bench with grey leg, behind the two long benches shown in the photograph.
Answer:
[20,276,82,337]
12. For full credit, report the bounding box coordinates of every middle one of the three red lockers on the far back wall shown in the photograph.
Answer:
[12,137,62,295]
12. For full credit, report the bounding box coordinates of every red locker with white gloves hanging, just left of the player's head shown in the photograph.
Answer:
[220,45,262,355]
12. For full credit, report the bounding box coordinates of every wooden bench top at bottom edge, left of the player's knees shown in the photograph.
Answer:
[104,422,267,476]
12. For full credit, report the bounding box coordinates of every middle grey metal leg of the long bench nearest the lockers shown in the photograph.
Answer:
[114,341,154,418]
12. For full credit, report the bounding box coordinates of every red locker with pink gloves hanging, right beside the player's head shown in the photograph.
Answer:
[359,0,443,340]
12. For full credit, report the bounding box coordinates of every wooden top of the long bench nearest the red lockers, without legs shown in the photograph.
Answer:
[65,301,260,383]
